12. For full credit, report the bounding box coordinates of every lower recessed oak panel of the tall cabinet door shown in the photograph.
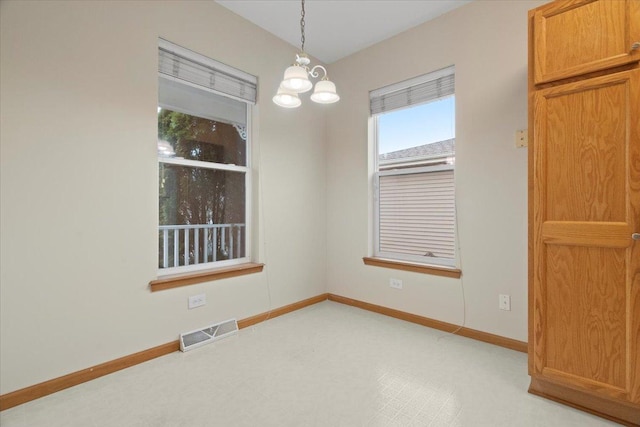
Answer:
[545,245,627,396]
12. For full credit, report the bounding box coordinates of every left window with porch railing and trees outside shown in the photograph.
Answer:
[158,40,257,275]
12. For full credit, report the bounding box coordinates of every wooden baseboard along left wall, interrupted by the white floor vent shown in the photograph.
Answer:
[0,294,328,411]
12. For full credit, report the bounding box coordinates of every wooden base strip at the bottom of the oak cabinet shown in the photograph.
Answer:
[529,375,640,427]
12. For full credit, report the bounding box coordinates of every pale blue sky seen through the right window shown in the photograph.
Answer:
[378,95,456,154]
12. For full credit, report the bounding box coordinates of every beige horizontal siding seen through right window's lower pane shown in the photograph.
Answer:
[378,168,455,263]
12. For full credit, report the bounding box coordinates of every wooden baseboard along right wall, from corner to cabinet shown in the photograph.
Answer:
[329,294,527,353]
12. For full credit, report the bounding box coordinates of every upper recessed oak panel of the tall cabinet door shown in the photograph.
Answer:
[545,80,629,222]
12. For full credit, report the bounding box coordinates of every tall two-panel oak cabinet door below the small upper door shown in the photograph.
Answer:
[530,69,640,406]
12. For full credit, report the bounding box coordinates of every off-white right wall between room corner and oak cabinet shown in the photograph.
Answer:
[327,0,542,341]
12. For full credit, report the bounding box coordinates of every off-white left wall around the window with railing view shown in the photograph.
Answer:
[0,1,326,394]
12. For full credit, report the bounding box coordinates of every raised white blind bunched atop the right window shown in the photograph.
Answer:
[369,66,455,115]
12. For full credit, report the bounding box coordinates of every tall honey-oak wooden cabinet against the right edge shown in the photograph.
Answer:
[529,0,640,426]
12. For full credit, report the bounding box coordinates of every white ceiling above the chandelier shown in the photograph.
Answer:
[216,0,471,64]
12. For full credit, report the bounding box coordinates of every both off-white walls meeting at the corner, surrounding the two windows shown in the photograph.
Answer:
[0,0,542,394]
